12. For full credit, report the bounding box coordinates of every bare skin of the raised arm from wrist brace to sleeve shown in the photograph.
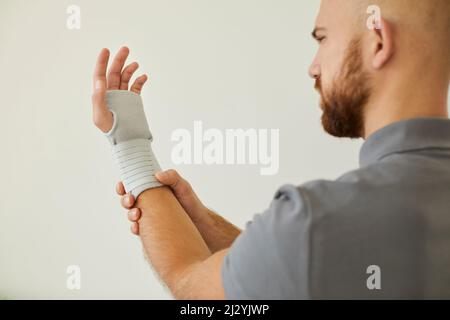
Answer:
[132,187,229,299]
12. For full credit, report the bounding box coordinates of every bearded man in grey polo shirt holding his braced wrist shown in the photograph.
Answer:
[93,0,450,299]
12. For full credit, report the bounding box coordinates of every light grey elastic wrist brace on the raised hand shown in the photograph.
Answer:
[105,90,162,199]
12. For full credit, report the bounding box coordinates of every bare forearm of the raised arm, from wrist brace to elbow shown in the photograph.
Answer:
[136,187,211,292]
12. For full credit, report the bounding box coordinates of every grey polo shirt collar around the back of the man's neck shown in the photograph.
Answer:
[359,118,450,167]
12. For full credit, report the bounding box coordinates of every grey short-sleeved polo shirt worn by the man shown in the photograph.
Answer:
[222,118,450,299]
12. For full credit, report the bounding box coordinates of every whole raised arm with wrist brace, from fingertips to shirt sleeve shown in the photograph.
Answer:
[92,47,227,299]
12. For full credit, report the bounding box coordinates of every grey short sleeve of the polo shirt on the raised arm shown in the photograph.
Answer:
[221,185,310,300]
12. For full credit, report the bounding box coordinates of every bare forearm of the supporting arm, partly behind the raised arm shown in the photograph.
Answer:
[195,209,242,253]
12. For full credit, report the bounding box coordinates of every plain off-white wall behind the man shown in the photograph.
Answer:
[0,0,376,299]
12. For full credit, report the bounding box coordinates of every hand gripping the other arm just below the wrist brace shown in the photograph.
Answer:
[116,169,209,235]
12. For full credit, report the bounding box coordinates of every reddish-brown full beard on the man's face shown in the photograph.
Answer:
[315,39,371,138]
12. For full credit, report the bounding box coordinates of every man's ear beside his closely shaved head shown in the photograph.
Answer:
[370,18,394,69]
